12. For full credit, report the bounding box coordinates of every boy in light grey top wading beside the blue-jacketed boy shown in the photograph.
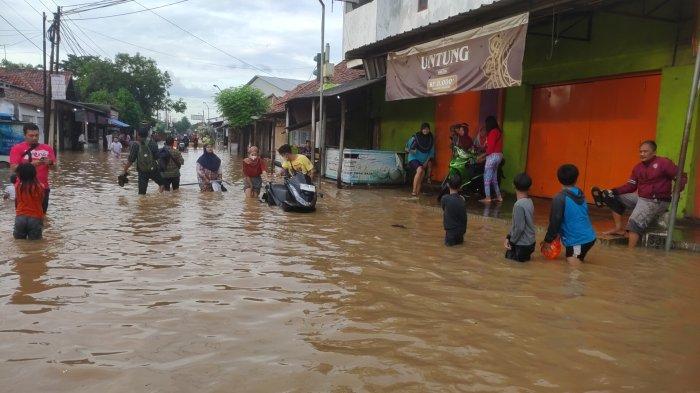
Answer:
[504,173,535,262]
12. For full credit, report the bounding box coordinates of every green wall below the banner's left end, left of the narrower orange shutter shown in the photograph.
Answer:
[372,86,435,151]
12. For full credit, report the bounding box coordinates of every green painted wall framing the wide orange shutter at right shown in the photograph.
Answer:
[503,9,698,215]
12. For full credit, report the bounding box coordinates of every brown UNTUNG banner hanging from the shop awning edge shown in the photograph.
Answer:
[386,13,528,101]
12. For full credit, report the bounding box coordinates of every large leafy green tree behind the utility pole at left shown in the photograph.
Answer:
[62,53,173,121]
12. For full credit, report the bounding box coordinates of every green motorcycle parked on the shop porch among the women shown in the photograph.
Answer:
[438,144,505,202]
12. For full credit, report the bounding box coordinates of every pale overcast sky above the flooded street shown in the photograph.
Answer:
[0,0,343,120]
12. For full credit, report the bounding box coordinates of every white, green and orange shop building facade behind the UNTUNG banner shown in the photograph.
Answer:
[343,0,700,217]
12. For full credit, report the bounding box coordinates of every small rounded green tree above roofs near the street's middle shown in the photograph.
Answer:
[215,85,269,127]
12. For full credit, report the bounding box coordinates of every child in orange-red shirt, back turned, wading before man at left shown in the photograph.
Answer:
[13,163,45,240]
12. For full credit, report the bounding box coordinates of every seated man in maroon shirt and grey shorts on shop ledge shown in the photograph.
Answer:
[605,141,687,248]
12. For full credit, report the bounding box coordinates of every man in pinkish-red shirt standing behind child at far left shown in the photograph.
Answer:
[10,124,56,213]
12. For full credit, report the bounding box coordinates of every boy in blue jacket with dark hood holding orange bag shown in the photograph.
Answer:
[544,164,596,262]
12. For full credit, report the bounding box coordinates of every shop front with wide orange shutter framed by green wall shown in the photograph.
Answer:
[503,0,699,217]
